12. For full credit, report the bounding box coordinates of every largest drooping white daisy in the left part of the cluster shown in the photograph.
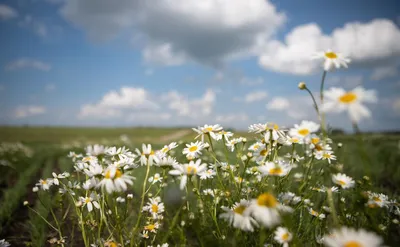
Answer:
[96,165,134,194]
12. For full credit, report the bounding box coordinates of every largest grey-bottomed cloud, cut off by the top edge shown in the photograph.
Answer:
[61,0,286,66]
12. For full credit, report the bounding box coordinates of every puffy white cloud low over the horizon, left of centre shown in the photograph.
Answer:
[79,87,159,118]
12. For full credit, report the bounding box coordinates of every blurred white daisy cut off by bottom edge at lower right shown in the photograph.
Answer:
[323,227,383,247]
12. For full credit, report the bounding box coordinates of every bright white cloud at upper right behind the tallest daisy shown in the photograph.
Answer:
[259,19,400,75]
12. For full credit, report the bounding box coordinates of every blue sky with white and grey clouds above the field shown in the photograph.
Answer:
[0,0,400,131]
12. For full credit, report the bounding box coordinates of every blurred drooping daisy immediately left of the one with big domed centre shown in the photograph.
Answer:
[219,199,258,232]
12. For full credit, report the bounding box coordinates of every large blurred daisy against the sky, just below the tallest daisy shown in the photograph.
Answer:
[320,87,377,123]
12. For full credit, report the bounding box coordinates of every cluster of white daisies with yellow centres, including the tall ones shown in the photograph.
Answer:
[23,51,400,247]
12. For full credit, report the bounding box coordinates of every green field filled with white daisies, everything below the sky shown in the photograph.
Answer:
[0,51,400,247]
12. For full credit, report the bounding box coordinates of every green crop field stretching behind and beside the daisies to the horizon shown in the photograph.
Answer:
[0,127,400,246]
